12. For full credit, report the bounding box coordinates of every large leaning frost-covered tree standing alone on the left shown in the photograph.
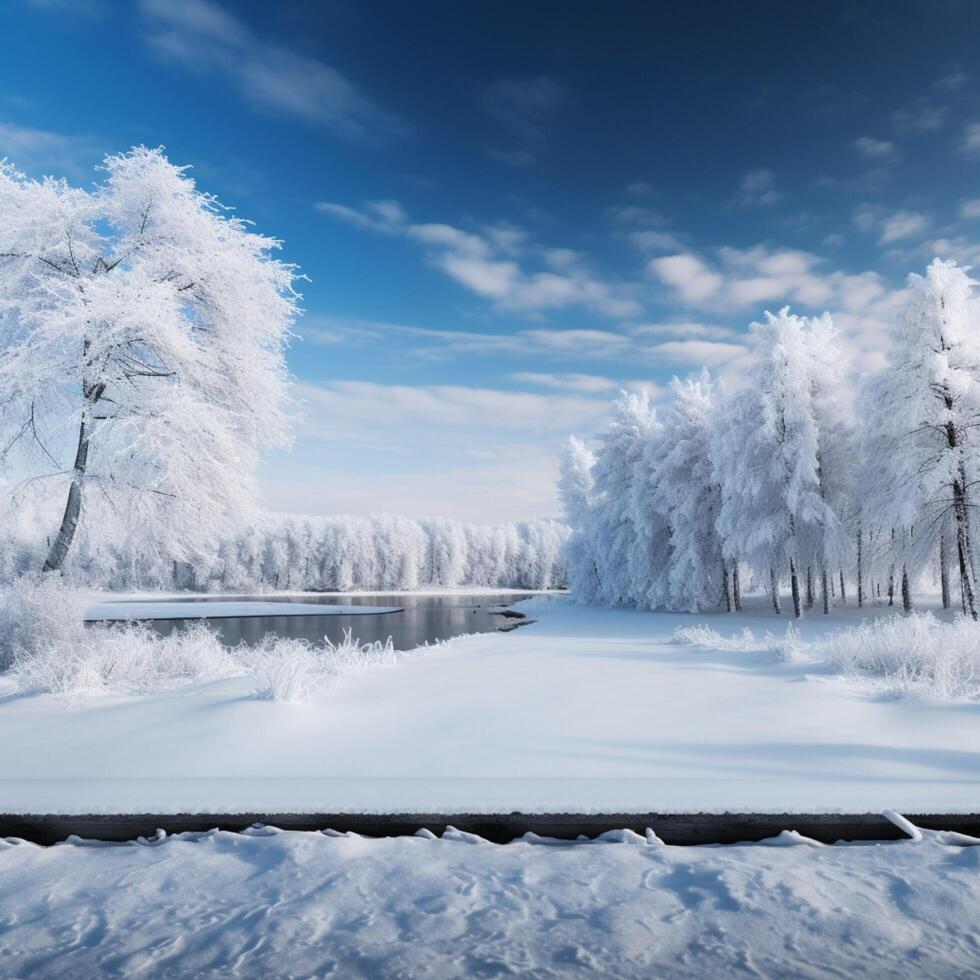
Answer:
[0,147,298,570]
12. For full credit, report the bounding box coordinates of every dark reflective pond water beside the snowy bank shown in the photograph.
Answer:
[142,593,526,650]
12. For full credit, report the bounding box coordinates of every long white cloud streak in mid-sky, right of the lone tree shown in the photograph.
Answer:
[315,201,641,317]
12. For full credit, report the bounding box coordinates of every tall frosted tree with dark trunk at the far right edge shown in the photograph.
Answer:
[866,259,980,619]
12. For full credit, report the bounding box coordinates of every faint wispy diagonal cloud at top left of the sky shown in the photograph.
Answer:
[140,0,406,140]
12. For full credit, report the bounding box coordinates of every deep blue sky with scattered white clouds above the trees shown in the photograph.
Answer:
[0,0,980,520]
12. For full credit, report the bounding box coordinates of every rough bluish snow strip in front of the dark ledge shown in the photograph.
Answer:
[0,830,980,980]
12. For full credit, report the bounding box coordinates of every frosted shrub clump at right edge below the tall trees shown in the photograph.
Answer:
[826,613,980,701]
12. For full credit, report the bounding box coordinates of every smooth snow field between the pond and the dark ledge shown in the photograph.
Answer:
[0,598,980,813]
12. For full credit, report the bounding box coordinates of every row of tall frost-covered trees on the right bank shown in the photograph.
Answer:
[559,259,980,619]
